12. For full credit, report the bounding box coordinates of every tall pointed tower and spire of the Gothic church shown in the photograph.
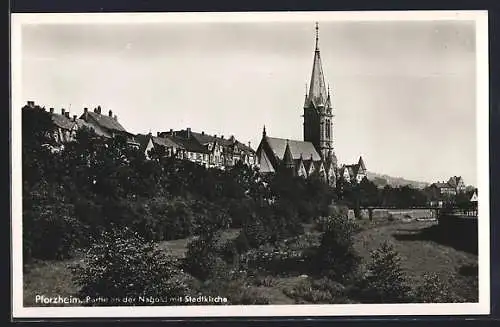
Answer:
[303,23,337,165]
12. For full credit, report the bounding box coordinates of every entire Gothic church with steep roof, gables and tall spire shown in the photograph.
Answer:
[256,23,366,186]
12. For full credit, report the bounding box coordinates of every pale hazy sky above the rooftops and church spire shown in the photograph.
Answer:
[21,20,477,185]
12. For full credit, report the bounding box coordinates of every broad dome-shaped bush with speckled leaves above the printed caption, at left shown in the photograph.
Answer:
[71,229,190,305]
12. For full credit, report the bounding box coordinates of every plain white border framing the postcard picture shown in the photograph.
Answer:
[11,11,490,318]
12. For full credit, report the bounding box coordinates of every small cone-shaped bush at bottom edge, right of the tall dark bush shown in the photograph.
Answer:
[361,242,410,303]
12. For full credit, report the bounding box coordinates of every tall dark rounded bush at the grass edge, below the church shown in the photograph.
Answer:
[317,216,361,281]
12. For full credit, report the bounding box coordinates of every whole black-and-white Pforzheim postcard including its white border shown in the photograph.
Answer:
[11,11,490,317]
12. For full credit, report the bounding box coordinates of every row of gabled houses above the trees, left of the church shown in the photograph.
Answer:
[26,101,256,169]
